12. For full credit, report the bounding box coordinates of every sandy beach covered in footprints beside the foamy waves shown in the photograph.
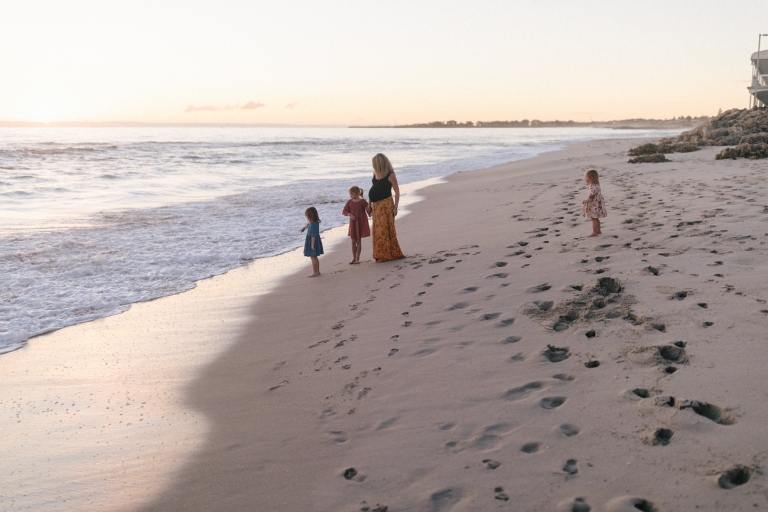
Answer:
[0,140,768,512]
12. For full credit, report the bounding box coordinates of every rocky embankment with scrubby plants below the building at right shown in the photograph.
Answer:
[629,108,768,164]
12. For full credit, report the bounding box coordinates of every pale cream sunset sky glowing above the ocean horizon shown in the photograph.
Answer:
[0,0,768,125]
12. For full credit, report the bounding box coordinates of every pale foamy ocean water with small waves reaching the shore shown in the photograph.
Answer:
[0,127,677,354]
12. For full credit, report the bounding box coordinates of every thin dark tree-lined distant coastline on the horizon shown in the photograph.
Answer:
[350,116,711,130]
